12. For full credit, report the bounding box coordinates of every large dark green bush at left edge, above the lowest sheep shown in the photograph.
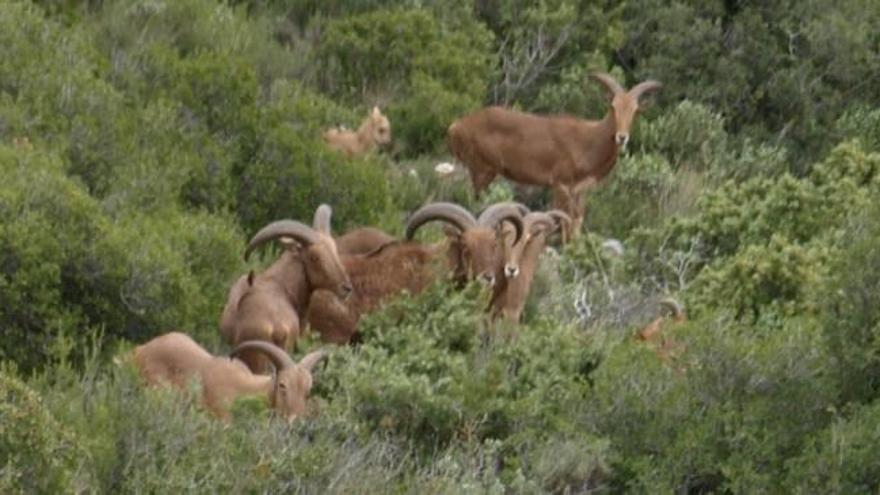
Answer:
[0,147,243,369]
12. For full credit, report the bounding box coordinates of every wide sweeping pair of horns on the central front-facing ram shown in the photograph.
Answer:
[406,202,528,242]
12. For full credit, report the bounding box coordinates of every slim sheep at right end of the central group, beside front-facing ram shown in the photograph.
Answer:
[490,210,571,322]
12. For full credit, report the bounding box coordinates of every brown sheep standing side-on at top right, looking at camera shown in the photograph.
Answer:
[446,73,661,240]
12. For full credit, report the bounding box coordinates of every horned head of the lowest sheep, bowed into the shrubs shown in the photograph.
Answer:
[230,340,327,421]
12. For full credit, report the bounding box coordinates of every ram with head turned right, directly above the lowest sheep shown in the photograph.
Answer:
[220,205,352,373]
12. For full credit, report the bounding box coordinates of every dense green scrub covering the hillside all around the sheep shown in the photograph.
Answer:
[0,0,880,493]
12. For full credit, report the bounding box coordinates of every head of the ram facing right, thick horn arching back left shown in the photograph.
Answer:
[245,205,352,299]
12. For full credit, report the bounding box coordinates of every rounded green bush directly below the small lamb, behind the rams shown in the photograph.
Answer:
[238,83,390,232]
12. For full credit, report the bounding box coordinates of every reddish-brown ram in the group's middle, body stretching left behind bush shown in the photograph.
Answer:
[308,203,523,343]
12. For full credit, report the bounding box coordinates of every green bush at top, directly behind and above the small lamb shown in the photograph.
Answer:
[317,8,492,155]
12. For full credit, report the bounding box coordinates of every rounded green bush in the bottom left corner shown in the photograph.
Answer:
[0,371,88,493]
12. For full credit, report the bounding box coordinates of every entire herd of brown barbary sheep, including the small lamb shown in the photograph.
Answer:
[133,74,683,420]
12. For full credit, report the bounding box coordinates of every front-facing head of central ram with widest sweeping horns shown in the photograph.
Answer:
[406,203,523,286]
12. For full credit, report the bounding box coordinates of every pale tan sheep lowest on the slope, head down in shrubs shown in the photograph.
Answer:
[134,332,326,421]
